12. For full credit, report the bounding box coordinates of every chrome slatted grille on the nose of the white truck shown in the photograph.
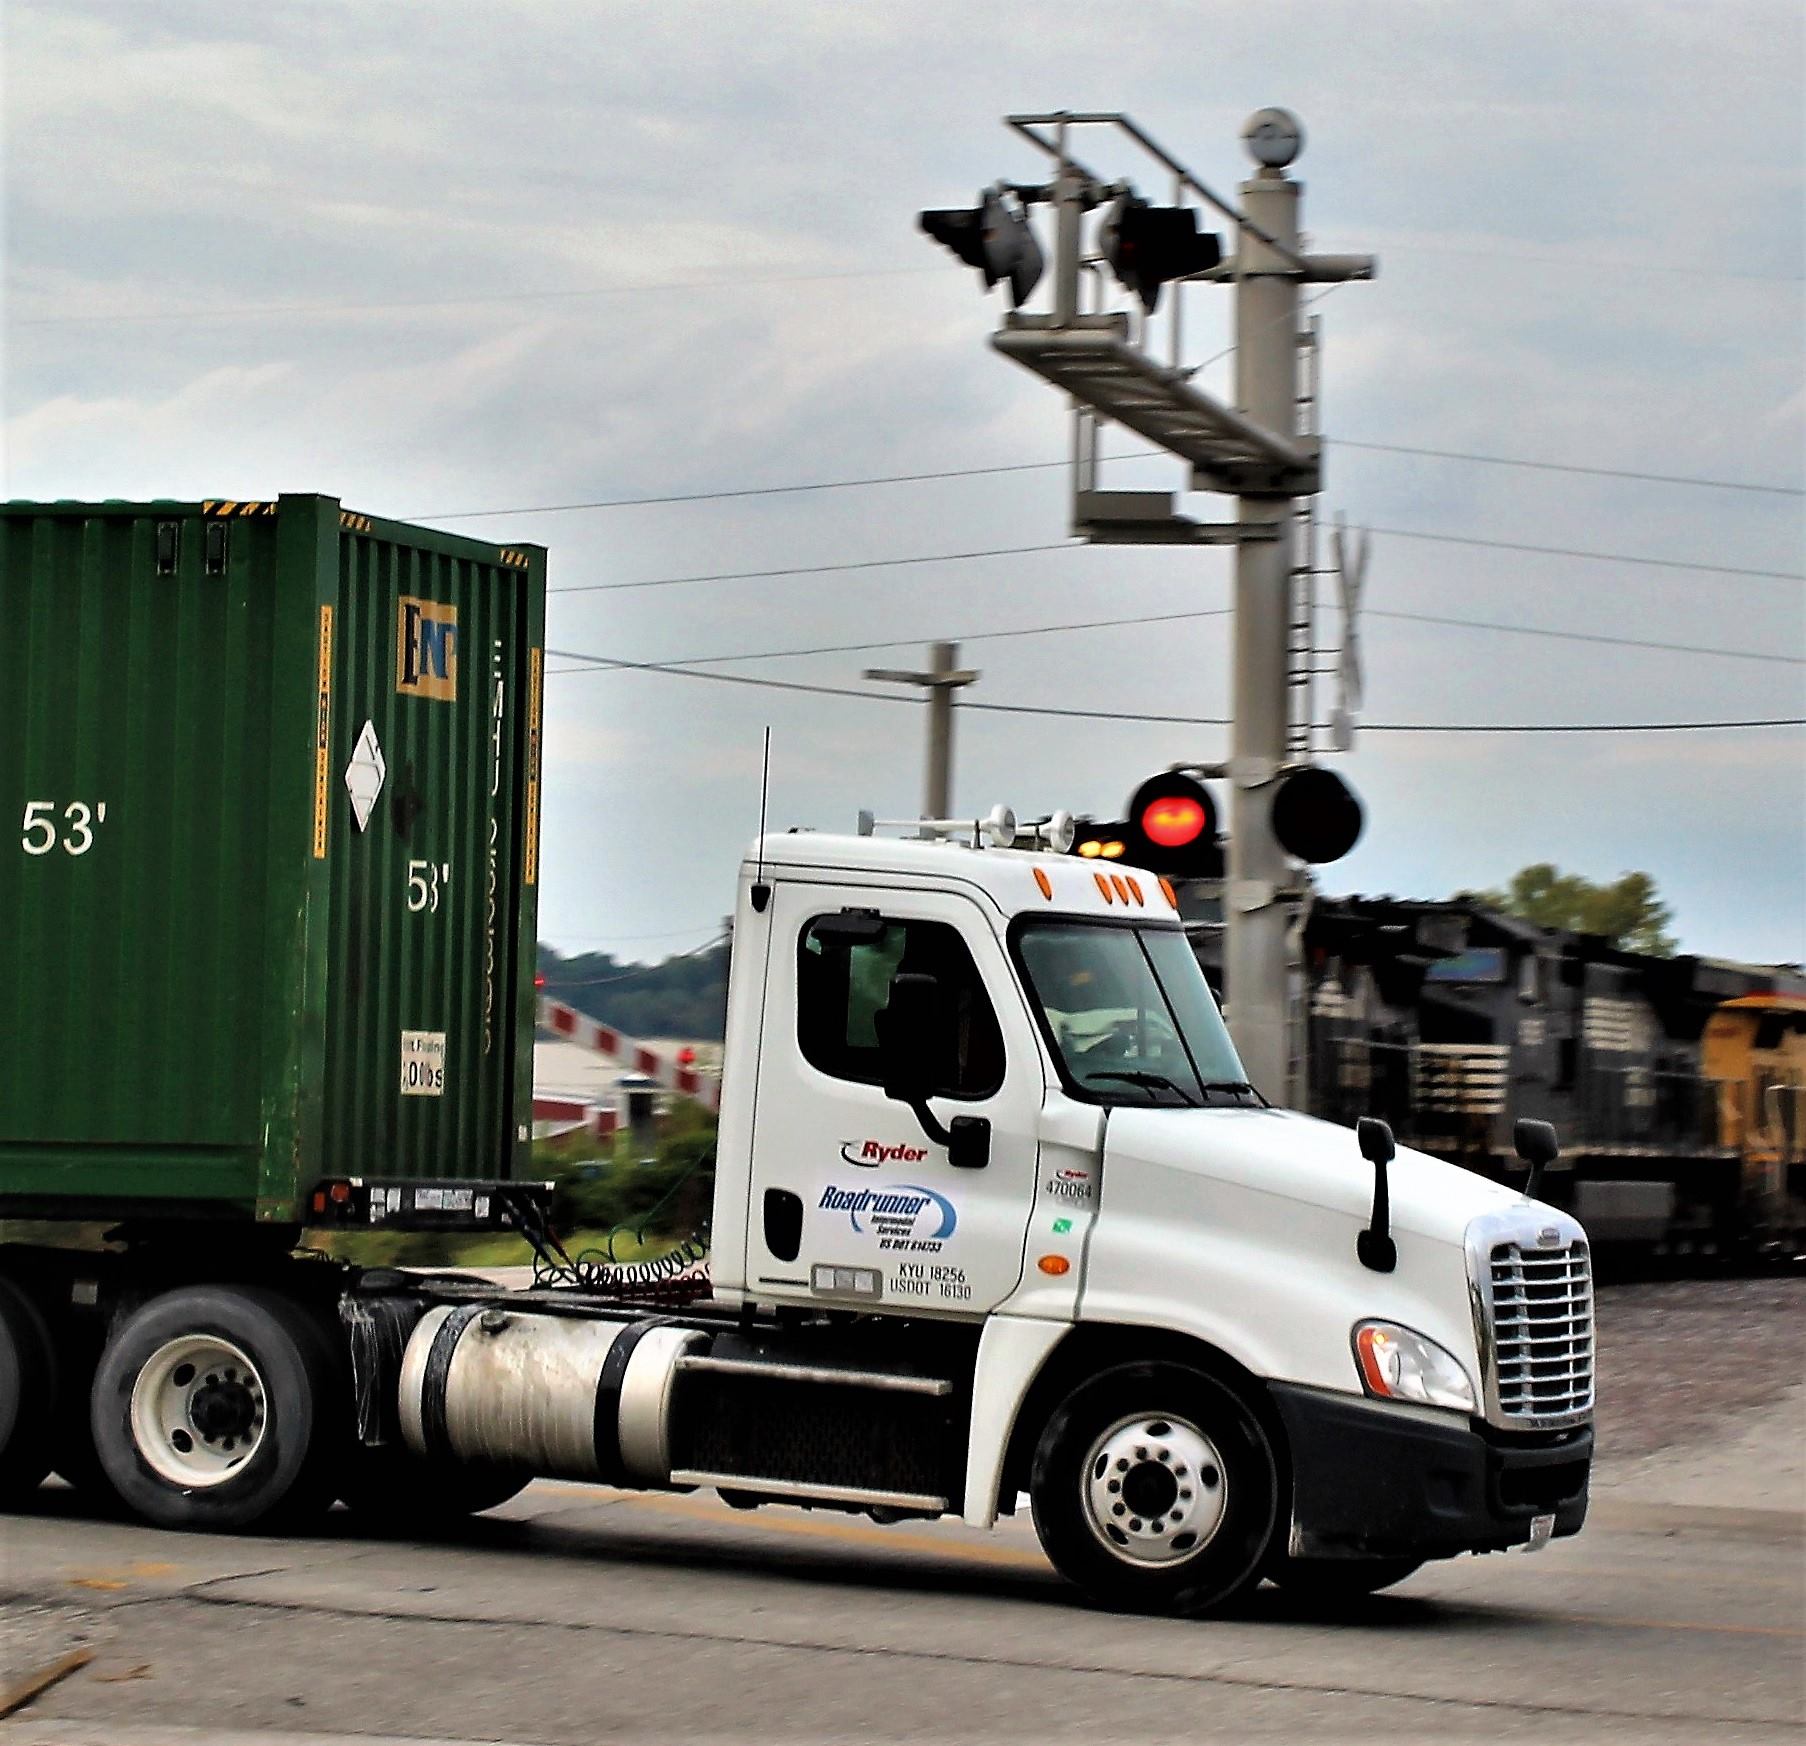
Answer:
[1490,1242,1593,1423]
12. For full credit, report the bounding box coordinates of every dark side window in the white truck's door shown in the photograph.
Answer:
[796,917,1004,1100]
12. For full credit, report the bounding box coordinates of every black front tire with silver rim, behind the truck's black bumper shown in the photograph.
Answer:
[1029,1363,1279,1618]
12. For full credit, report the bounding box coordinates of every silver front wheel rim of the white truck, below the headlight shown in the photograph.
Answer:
[1080,1412,1228,1565]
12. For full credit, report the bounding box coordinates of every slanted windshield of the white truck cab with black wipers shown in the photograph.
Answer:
[1017,921,1250,1105]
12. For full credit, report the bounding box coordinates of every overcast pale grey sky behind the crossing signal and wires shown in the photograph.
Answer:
[0,0,1806,961]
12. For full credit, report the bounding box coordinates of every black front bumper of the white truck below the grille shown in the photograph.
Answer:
[1271,1383,1593,1558]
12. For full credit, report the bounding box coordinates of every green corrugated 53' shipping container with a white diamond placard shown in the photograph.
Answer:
[0,497,545,1224]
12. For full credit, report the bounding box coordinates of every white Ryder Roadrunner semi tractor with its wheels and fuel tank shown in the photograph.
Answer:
[0,814,1593,1614]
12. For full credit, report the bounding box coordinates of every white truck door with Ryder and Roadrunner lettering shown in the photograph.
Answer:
[746,883,1044,1314]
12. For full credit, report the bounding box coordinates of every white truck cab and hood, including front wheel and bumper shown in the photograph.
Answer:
[693,822,1593,1609]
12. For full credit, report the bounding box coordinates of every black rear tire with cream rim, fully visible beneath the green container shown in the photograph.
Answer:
[90,1286,347,1533]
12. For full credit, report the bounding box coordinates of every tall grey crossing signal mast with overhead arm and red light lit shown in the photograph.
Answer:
[921,108,1374,1092]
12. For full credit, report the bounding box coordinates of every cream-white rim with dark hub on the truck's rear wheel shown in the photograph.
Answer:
[132,1334,269,1490]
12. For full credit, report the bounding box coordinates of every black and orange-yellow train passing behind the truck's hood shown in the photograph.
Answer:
[1271,897,1806,1255]
